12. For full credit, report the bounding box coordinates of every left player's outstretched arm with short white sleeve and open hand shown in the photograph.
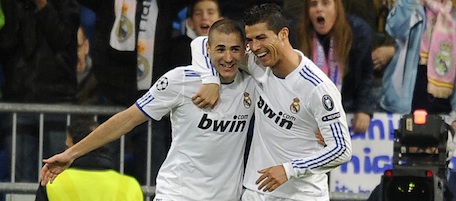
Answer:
[40,68,185,185]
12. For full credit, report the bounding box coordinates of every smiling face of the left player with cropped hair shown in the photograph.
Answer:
[207,31,245,83]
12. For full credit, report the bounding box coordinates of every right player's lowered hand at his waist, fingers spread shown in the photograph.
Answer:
[255,165,288,192]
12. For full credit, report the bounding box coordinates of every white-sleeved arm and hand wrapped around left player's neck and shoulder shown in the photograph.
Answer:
[190,36,220,108]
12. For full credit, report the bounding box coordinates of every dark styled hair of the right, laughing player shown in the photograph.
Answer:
[244,3,288,34]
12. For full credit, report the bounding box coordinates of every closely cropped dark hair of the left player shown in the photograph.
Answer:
[208,18,245,44]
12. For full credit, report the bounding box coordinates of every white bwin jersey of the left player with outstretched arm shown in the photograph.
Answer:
[136,67,255,201]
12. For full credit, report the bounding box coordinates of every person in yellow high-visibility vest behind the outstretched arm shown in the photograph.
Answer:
[35,120,144,201]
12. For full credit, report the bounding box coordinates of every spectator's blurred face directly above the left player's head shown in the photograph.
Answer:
[188,0,221,36]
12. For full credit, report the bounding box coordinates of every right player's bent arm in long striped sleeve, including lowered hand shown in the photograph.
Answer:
[256,86,351,191]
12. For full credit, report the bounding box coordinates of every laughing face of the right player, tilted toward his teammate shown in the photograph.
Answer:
[245,23,282,67]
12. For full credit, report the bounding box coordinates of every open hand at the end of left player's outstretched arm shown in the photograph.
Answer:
[40,152,73,186]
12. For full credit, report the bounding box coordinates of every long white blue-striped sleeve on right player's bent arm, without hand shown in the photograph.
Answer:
[283,84,351,178]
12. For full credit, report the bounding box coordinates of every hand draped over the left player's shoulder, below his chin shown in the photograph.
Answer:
[192,84,220,109]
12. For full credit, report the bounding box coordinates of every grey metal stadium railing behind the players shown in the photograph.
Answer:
[0,103,367,201]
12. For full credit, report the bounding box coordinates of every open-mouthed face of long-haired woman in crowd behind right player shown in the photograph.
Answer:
[308,0,337,35]
